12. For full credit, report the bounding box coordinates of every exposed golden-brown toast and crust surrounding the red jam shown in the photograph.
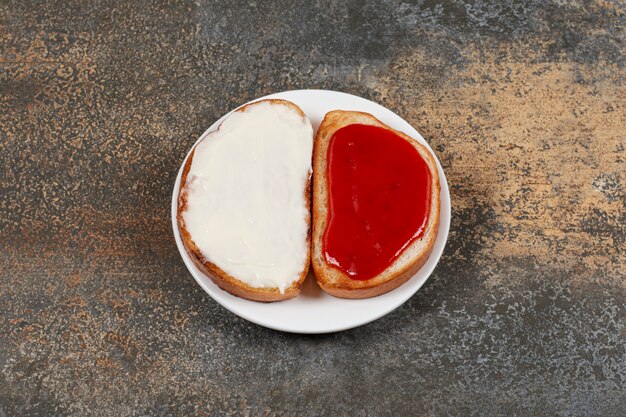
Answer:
[312,110,440,298]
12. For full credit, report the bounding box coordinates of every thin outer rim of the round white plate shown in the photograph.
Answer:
[170,89,452,334]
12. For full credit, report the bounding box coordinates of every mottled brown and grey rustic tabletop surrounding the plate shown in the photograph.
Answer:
[0,0,626,417]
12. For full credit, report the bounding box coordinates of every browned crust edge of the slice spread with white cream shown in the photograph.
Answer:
[176,99,311,302]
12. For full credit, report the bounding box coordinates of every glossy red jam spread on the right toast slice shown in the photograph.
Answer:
[323,124,432,280]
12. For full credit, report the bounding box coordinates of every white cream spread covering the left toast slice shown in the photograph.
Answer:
[182,102,313,293]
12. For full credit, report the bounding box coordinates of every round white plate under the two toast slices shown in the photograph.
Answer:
[172,90,450,334]
